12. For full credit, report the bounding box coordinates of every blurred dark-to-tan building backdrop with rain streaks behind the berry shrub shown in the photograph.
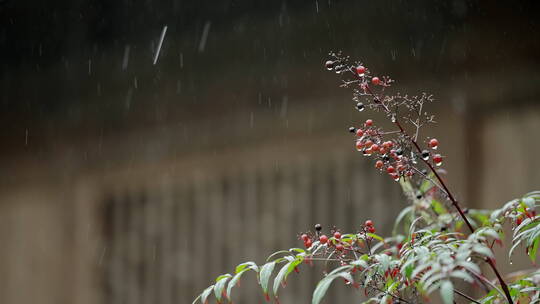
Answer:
[0,0,540,304]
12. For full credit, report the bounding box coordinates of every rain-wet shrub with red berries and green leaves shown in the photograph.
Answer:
[193,53,540,304]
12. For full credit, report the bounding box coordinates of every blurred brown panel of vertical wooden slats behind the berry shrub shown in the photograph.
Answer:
[99,154,404,304]
